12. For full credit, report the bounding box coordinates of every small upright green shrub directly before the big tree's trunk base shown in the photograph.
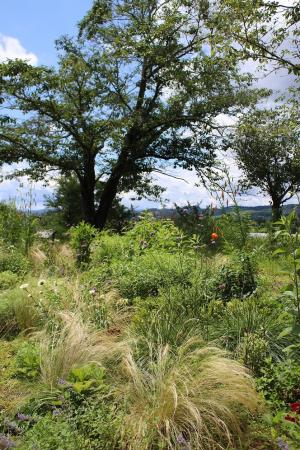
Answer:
[71,222,96,267]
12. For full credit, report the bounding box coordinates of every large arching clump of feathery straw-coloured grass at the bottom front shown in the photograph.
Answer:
[119,338,259,450]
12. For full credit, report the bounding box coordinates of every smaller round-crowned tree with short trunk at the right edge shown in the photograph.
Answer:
[233,106,300,220]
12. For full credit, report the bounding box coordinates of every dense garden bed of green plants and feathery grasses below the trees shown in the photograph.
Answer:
[0,206,300,450]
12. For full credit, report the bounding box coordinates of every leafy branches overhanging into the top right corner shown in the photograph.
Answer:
[214,0,300,75]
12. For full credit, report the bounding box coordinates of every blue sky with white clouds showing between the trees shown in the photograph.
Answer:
[0,0,291,209]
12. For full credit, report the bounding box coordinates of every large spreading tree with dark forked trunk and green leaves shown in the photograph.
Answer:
[0,0,257,228]
